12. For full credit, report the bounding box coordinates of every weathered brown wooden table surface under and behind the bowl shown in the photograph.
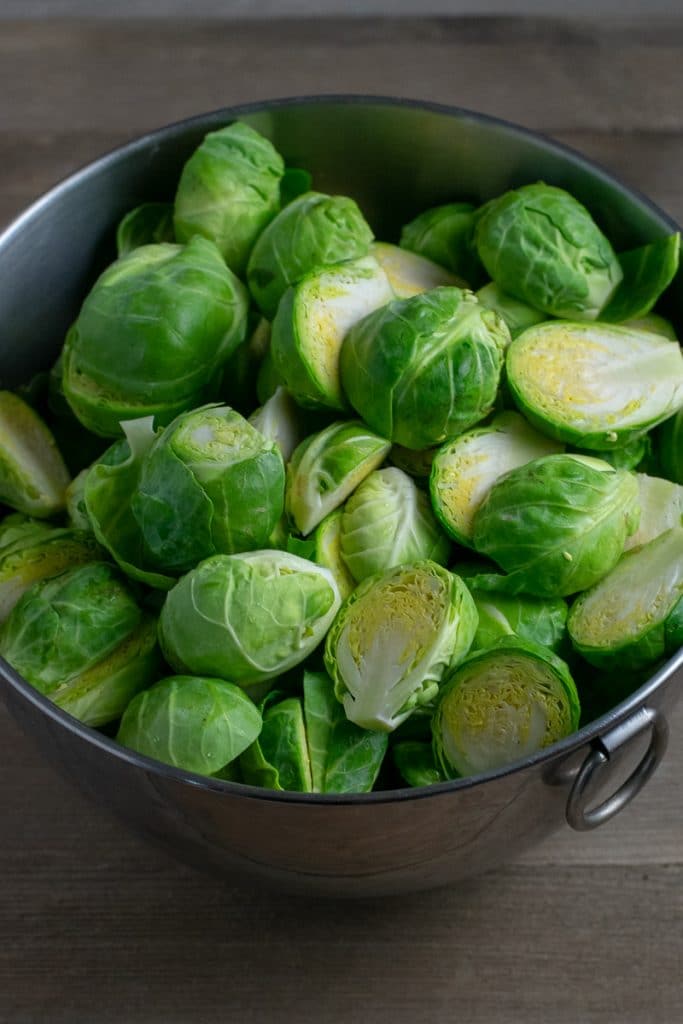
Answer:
[0,18,683,1024]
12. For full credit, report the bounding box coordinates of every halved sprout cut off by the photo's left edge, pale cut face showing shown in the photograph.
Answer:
[0,391,70,518]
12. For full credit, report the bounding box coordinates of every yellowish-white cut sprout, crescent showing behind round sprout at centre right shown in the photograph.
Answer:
[429,412,563,548]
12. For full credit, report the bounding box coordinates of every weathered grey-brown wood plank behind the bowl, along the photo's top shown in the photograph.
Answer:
[0,18,683,141]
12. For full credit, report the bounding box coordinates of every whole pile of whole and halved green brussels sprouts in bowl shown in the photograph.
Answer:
[0,122,683,793]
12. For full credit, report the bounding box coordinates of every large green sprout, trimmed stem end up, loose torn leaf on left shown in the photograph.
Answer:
[85,406,285,587]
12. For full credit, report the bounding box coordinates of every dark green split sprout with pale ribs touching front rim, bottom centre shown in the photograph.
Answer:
[241,672,388,793]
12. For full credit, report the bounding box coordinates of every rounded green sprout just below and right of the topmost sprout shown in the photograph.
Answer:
[247,191,373,319]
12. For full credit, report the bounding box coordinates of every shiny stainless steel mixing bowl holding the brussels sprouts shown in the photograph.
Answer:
[0,96,683,896]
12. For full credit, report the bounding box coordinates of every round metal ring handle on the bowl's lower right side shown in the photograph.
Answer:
[566,708,669,831]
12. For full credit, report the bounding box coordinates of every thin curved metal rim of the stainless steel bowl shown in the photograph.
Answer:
[0,93,683,807]
